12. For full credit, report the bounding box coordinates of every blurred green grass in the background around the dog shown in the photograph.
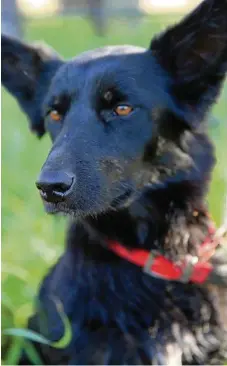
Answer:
[2,13,227,364]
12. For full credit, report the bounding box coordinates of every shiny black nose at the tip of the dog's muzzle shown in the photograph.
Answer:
[36,172,75,203]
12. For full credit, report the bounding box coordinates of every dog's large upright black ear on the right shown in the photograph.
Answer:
[150,0,227,123]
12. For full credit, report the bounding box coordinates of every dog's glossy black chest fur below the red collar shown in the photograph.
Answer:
[30,216,226,365]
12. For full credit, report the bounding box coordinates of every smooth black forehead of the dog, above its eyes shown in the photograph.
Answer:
[45,46,169,108]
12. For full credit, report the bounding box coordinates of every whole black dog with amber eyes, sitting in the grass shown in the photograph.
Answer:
[2,0,227,365]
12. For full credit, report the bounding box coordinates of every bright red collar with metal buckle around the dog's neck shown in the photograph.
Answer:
[107,219,222,284]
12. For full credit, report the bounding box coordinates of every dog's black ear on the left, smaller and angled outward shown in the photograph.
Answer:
[2,35,63,137]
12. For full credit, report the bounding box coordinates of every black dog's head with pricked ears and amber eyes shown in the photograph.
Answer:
[2,0,227,215]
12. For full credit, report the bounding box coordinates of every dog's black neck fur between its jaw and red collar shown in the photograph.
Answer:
[86,182,210,260]
